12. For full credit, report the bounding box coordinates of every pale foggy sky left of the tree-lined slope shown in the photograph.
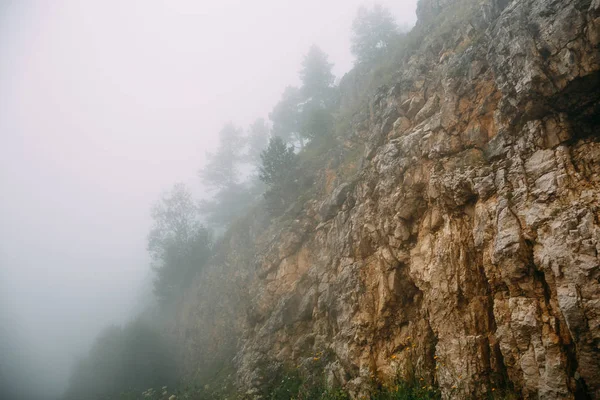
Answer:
[0,0,416,399]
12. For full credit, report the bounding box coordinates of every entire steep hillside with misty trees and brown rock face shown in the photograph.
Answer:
[65,0,600,400]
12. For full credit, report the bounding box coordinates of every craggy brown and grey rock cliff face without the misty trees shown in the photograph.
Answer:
[177,0,600,399]
